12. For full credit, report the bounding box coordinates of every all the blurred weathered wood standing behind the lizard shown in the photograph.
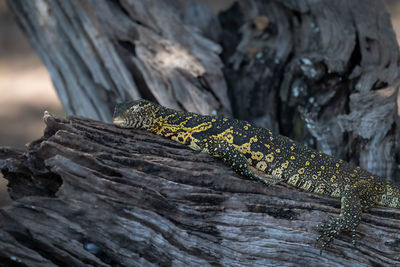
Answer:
[8,0,400,182]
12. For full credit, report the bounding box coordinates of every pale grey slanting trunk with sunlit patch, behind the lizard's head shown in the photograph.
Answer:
[8,0,231,122]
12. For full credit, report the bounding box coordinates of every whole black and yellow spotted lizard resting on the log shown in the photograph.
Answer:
[113,100,400,249]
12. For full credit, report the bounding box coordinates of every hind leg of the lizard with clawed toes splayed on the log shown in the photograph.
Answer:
[317,185,362,253]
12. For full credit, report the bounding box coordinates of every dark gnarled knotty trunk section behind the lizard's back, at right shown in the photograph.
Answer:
[220,0,400,182]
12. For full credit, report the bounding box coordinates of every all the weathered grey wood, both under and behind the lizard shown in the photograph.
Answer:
[4,0,400,266]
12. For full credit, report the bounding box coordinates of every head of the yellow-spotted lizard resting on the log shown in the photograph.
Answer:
[113,99,158,129]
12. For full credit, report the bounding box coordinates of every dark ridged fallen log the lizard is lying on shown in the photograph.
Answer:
[0,113,400,266]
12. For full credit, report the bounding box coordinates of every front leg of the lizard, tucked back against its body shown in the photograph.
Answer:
[205,139,281,186]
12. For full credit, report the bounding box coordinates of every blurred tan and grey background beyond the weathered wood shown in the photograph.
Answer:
[0,0,400,207]
